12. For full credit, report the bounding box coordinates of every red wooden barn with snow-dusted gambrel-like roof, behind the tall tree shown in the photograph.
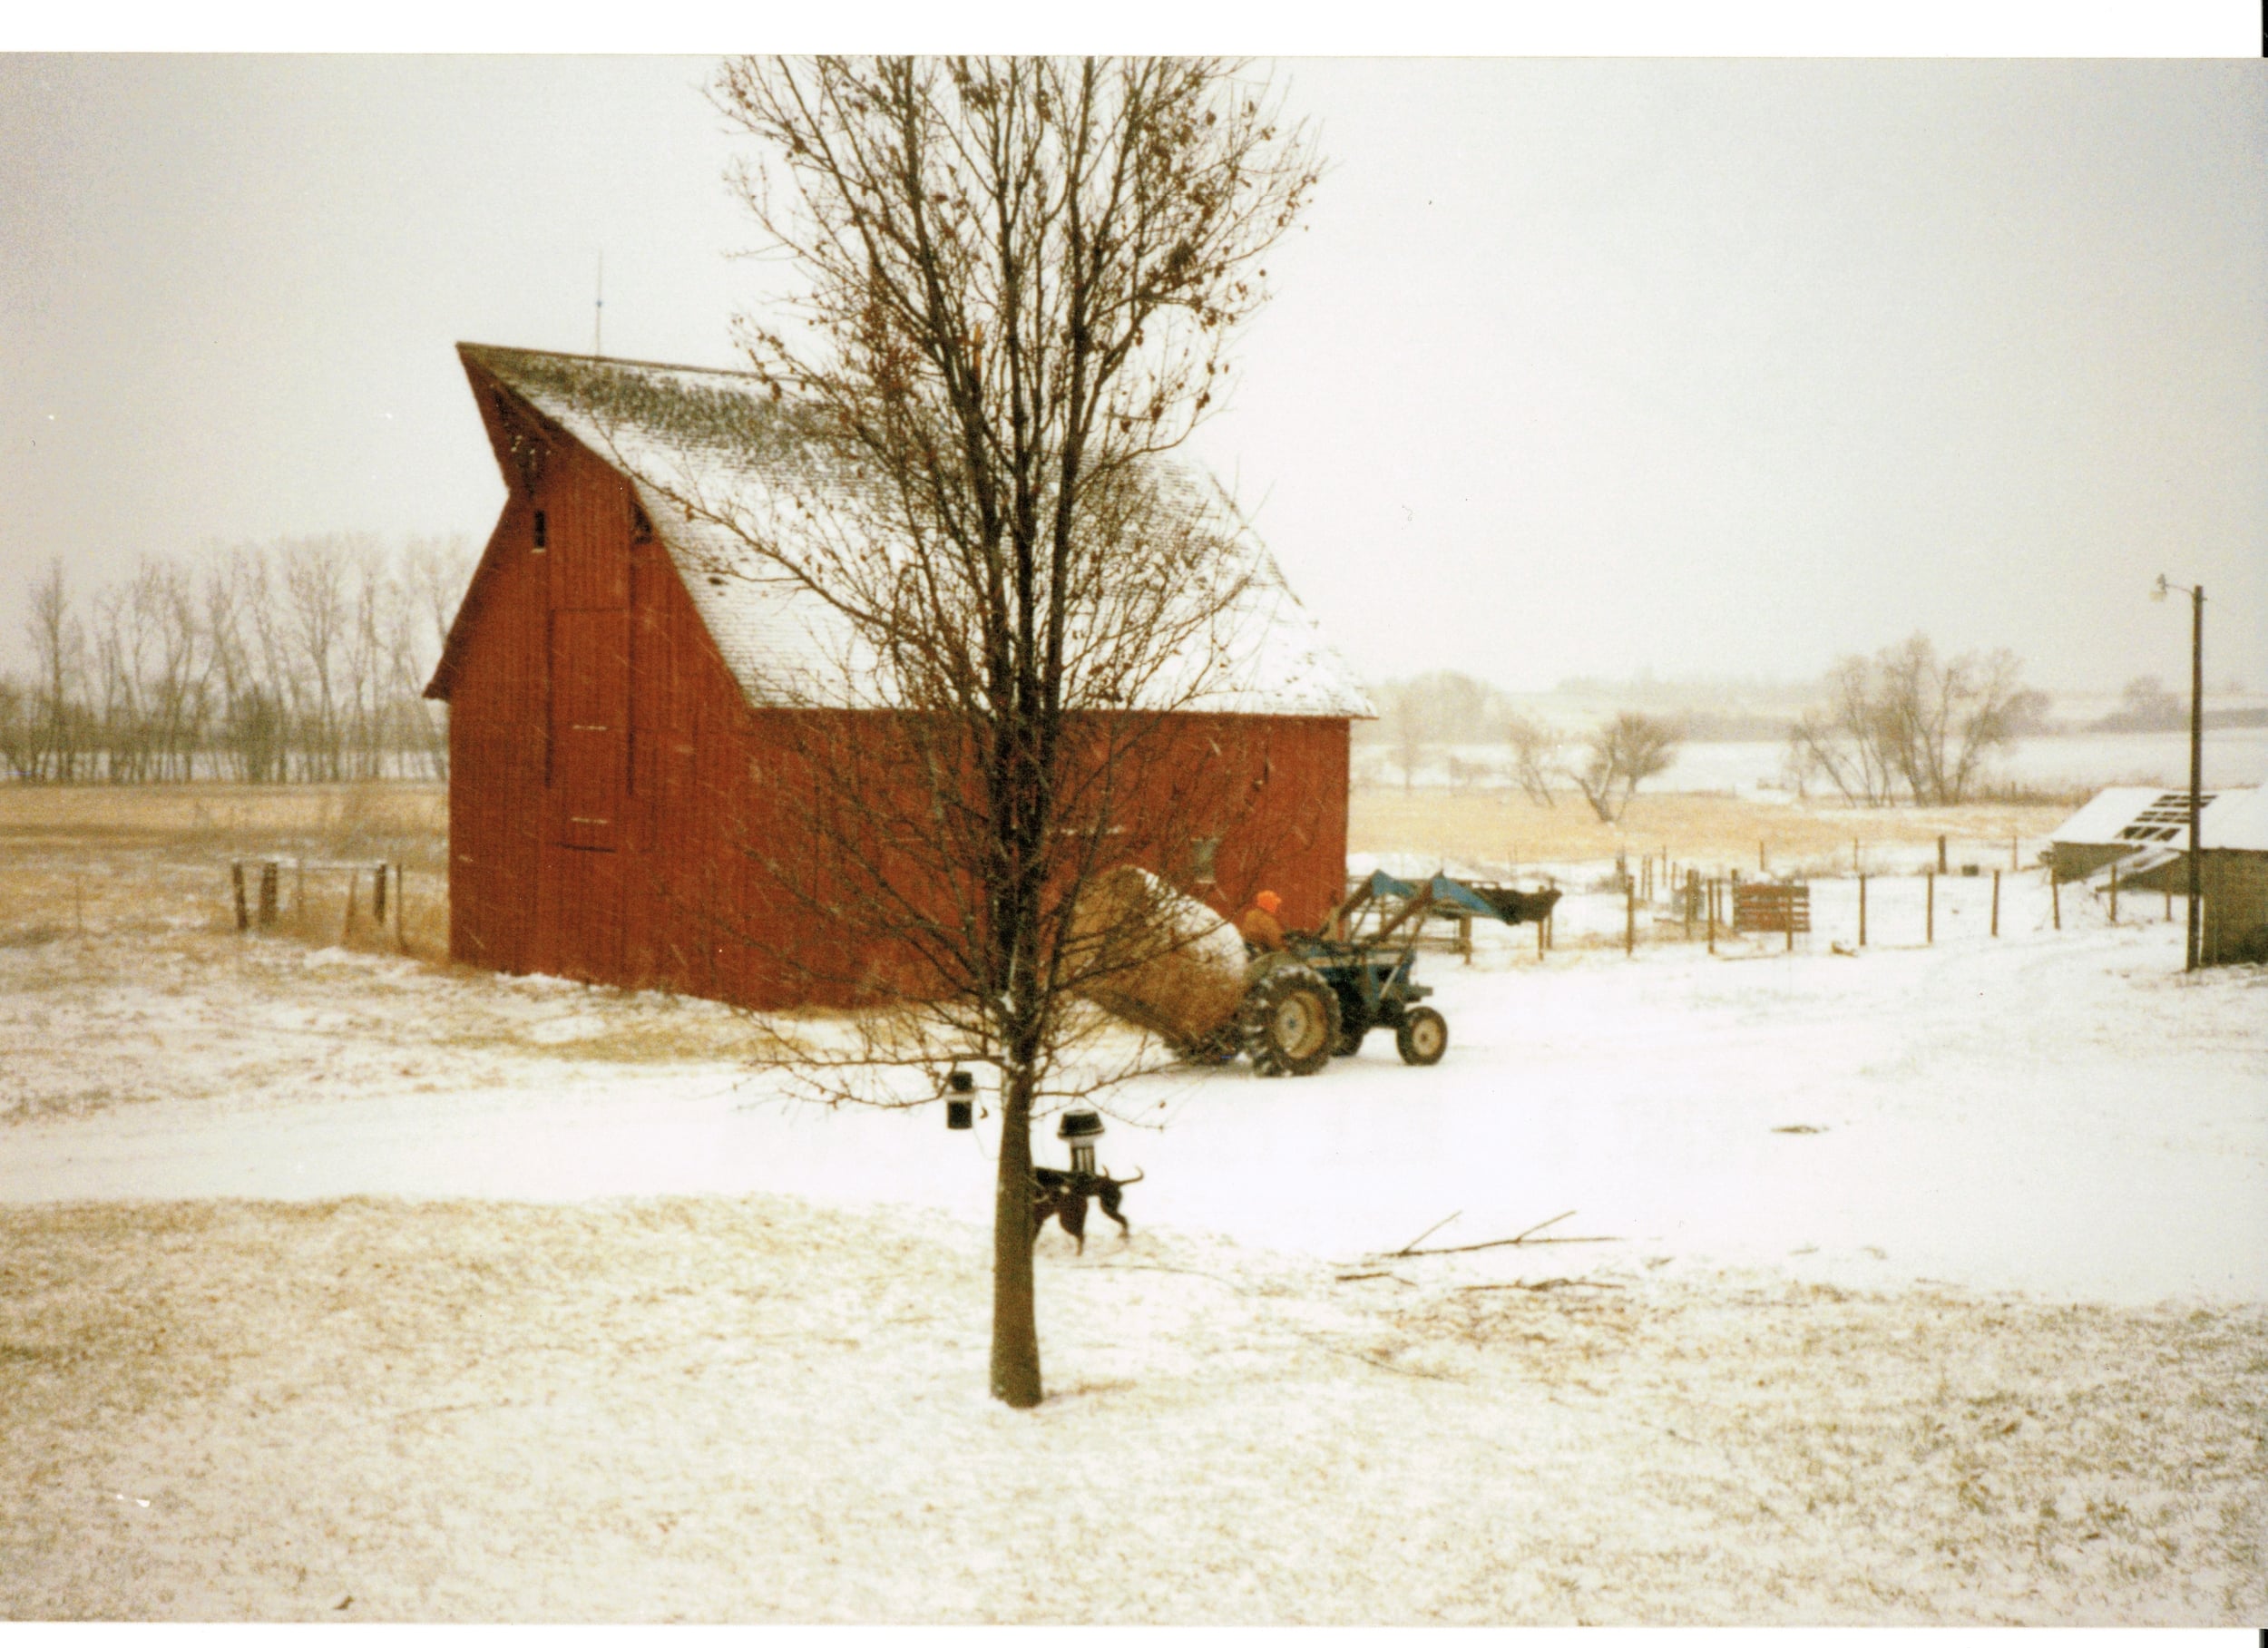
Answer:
[426,345,1373,1007]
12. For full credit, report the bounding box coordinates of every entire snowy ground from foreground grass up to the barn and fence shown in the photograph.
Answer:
[0,843,2268,1624]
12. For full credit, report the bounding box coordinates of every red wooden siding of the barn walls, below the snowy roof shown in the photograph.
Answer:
[435,369,1347,1007]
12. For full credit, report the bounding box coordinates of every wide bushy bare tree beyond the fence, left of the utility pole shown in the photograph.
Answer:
[1790,635,2048,807]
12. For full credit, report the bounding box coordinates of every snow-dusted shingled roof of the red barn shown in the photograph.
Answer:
[458,345,1377,717]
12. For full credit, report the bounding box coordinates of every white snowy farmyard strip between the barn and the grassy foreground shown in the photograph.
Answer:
[0,873,2268,1302]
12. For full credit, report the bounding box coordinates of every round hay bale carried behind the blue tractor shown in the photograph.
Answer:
[1070,866,1246,1048]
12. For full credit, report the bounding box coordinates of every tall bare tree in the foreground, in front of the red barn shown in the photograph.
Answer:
[679,59,1315,1408]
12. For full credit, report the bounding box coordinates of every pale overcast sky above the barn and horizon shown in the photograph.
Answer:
[0,56,2268,689]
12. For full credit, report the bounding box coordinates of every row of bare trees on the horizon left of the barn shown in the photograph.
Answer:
[0,532,474,785]
